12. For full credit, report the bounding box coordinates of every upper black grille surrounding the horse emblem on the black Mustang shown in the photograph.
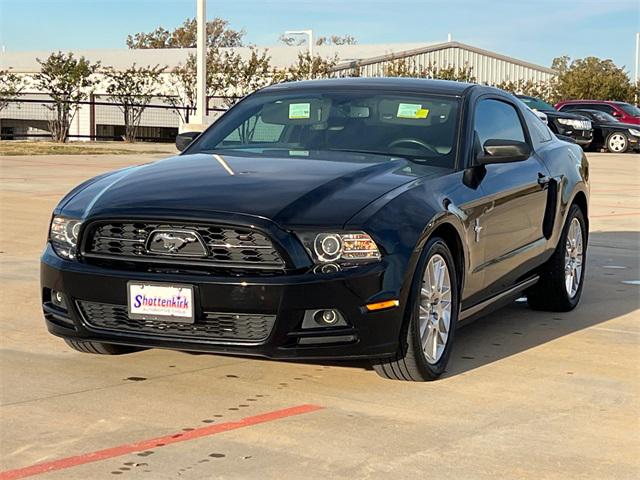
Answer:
[83,222,285,269]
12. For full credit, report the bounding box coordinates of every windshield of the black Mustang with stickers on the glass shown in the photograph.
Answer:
[187,90,459,168]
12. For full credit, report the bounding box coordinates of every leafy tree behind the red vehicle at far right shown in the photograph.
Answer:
[552,56,635,102]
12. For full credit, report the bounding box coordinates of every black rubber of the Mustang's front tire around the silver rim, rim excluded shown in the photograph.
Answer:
[373,237,459,382]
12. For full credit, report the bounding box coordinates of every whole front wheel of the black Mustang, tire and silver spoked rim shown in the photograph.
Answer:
[373,237,459,382]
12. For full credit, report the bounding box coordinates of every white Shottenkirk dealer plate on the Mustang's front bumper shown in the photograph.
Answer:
[127,282,195,323]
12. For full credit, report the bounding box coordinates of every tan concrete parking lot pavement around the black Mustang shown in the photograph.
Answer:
[0,148,640,479]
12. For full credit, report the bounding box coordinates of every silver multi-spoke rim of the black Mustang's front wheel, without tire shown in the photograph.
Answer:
[419,253,451,365]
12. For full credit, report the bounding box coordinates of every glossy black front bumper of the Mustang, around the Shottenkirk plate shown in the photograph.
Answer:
[41,245,404,359]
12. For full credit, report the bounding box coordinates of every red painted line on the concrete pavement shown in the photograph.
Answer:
[0,404,324,480]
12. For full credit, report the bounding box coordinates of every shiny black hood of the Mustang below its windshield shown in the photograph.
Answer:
[58,152,447,226]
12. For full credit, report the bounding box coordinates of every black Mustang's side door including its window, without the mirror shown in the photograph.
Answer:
[474,96,548,296]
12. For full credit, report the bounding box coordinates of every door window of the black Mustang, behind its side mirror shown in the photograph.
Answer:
[474,100,525,145]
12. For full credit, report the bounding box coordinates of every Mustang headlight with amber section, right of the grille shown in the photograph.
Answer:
[298,232,380,265]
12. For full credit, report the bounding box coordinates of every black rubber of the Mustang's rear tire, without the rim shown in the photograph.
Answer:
[527,204,588,312]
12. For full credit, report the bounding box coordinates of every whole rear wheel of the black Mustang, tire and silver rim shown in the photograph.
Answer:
[527,205,587,312]
